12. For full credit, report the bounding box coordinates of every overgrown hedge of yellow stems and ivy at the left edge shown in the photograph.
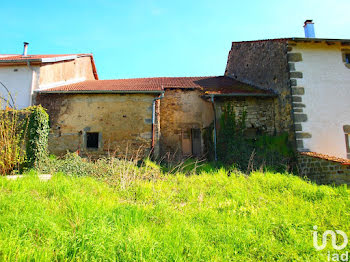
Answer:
[0,104,49,175]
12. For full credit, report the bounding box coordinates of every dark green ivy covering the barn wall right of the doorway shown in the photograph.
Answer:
[203,102,294,171]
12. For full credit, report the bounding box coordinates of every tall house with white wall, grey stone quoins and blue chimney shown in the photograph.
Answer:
[225,20,350,183]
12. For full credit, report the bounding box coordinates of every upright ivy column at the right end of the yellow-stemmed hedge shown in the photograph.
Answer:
[26,105,50,167]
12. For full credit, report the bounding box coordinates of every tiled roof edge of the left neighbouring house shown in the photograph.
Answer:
[0,54,98,79]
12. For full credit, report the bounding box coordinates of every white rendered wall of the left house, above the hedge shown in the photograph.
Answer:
[0,66,37,109]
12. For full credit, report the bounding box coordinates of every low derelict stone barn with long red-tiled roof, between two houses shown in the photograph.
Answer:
[36,76,276,159]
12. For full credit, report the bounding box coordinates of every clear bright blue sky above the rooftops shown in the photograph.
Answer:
[0,0,350,79]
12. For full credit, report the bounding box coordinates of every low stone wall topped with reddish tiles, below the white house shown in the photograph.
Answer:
[298,152,350,185]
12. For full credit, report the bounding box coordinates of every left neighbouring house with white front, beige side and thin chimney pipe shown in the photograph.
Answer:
[0,43,98,109]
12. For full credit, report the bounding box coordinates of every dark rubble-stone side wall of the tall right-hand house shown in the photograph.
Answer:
[225,40,294,141]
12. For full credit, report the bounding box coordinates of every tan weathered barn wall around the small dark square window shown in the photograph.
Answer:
[37,94,157,157]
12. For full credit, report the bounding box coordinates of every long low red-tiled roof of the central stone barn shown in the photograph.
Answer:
[38,76,274,95]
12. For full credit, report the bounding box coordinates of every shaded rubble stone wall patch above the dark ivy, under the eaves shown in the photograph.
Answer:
[215,97,276,137]
